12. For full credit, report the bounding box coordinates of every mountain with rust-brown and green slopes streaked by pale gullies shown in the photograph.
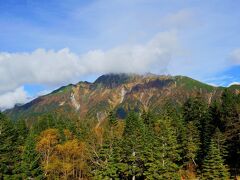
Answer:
[5,74,239,121]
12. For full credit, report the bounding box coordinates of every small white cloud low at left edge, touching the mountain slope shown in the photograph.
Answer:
[0,87,28,110]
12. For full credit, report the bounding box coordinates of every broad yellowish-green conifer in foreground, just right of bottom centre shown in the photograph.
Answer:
[144,116,180,179]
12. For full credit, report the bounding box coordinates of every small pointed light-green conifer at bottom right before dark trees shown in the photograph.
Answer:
[202,140,229,180]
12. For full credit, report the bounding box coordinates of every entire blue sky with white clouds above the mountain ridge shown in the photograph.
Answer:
[0,0,240,108]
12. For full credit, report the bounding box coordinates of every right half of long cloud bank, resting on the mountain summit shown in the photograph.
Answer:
[80,32,178,73]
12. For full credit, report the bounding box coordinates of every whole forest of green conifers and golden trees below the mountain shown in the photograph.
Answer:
[0,89,240,180]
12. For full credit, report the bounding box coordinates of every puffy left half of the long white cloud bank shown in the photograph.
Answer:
[0,49,81,94]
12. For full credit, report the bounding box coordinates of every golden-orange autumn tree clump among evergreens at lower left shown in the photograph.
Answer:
[36,129,87,180]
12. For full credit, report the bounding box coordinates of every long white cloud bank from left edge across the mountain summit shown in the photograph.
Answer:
[0,31,179,109]
